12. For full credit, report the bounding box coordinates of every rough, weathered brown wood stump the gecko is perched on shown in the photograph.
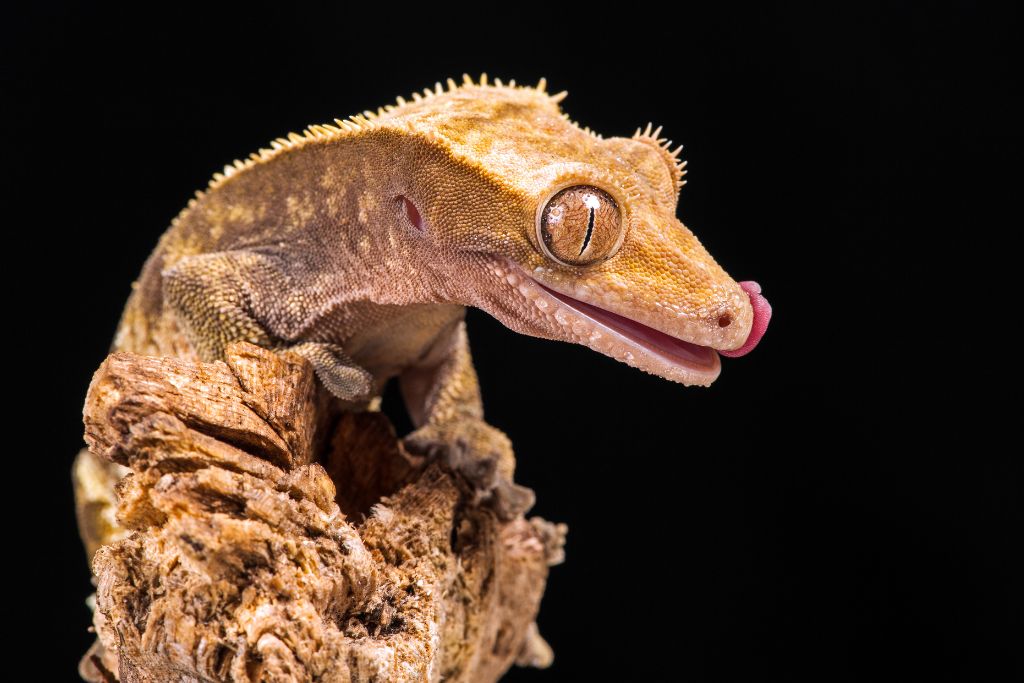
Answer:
[80,344,565,682]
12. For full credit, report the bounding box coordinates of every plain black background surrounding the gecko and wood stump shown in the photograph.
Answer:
[3,3,1024,682]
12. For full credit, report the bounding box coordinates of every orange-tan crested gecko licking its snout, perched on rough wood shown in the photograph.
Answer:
[76,75,771,544]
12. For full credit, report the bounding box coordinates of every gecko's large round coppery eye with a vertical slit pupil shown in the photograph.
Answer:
[538,185,623,265]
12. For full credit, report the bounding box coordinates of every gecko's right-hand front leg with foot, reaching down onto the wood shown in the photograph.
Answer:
[399,318,534,519]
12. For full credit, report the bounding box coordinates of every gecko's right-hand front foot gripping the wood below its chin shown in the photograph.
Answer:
[402,418,534,521]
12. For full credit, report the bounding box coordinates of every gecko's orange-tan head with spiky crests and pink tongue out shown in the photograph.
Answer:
[385,78,771,385]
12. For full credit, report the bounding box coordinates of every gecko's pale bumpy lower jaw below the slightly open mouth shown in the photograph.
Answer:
[495,267,721,386]
